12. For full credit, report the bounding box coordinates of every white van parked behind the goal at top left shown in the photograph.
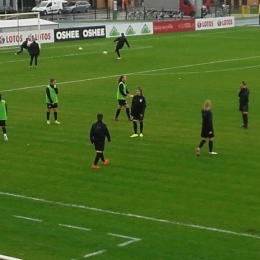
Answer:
[32,0,68,15]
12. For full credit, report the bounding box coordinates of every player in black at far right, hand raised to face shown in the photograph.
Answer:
[238,81,250,129]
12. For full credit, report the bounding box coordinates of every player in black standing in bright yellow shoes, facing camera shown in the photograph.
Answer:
[130,88,146,137]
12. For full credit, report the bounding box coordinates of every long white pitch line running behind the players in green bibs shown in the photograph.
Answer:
[1,56,260,92]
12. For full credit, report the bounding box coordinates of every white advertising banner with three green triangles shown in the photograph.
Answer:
[106,22,153,38]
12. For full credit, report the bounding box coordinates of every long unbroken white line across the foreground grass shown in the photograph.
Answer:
[0,191,260,239]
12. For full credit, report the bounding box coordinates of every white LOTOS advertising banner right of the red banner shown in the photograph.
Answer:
[195,16,235,31]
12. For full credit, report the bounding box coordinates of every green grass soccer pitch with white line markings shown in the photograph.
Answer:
[0,27,260,260]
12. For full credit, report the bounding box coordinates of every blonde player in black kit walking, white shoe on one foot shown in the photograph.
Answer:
[196,100,217,156]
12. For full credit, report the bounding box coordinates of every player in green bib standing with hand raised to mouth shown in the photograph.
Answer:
[46,79,60,125]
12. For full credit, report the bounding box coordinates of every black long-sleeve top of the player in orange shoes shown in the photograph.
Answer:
[89,121,111,144]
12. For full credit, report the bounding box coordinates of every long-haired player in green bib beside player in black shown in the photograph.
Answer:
[115,75,133,121]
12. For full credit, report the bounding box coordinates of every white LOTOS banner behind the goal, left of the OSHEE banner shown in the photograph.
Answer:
[0,29,54,48]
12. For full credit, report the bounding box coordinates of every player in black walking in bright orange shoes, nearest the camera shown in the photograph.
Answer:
[90,114,111,169]
